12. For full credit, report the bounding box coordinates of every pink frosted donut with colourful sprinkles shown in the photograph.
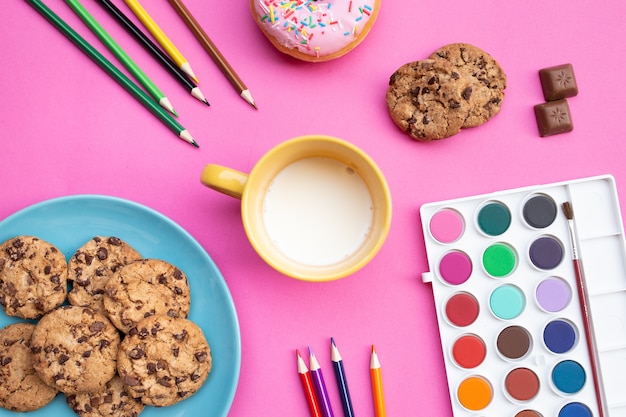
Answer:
[250,0,381,62]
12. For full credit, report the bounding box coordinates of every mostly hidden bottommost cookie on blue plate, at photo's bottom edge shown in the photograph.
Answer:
[66,375,144,417]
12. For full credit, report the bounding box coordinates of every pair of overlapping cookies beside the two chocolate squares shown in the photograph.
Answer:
[386,43,506,142]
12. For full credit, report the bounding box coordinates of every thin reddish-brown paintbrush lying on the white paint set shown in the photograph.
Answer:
[562,201,608,417]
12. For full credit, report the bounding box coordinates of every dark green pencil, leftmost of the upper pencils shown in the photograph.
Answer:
[26,0,198,147]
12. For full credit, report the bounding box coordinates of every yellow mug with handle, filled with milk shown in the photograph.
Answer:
[201,135,391,282]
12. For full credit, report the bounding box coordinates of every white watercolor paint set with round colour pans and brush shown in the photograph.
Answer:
[420,175,626,417]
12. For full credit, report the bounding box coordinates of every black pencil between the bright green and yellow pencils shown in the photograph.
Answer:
[98,0,209,106]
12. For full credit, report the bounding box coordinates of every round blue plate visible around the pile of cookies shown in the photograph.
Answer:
[0,195,241,417]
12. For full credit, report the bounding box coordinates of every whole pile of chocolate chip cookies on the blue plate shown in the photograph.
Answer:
[0,236,212,417]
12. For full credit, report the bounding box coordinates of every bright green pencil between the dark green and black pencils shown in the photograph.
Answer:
[65,0,178,116]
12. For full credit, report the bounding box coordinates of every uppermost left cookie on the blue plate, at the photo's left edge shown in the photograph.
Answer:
[0,236,67,319]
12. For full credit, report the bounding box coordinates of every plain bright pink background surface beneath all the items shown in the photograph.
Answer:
[0,0,626,417]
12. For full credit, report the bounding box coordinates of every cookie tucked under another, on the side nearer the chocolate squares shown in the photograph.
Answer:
[430,43,506,127]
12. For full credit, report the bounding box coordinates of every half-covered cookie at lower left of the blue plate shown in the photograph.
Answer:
[0,323,57,412]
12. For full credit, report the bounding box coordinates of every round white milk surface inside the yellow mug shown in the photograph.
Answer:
[263,157,373,266]
